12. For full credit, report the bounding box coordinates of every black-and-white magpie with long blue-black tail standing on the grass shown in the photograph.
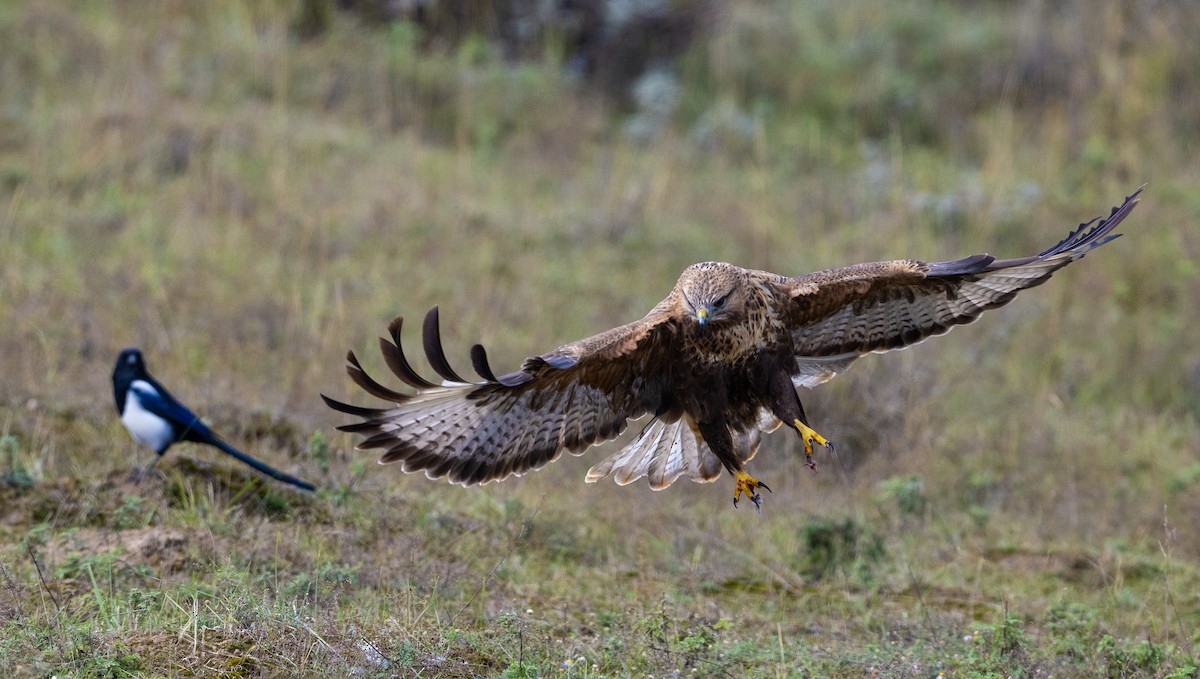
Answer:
[113,349,316,491]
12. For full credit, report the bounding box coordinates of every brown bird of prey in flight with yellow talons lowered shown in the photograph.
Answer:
[322,188,1141,506]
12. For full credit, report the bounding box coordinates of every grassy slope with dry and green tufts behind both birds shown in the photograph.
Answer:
[0,1,1200,677]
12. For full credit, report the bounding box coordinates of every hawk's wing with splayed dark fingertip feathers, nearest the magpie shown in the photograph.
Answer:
[322,305,673,486]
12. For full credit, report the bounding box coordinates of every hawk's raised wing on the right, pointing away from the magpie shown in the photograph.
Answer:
[787,188,1141,386]
